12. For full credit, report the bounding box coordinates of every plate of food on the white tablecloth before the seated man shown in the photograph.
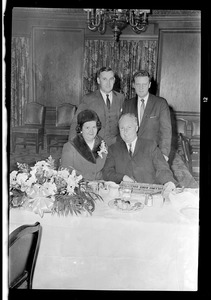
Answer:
[108,198,144,213]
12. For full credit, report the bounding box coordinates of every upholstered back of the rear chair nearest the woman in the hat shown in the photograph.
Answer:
[56,103,76,127]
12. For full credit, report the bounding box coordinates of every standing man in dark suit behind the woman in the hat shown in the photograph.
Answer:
[69,67,124,146]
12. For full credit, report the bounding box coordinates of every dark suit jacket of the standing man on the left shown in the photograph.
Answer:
[69,90,125,145]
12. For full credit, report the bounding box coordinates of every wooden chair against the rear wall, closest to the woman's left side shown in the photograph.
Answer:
[45,103,76,153]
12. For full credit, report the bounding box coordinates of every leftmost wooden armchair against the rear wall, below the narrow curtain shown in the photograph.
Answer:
[11,102,45,153]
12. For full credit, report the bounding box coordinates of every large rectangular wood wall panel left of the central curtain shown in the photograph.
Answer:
[32,26,84,106]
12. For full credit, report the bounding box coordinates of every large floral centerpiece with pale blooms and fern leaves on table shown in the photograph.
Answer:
[9,156,102,217]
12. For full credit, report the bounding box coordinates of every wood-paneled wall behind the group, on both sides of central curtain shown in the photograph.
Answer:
[9,8,201,118]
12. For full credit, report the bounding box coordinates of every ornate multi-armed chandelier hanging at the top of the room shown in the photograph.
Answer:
[84,8,150,41]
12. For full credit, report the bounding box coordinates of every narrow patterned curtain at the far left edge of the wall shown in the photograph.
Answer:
[10,37,29,127]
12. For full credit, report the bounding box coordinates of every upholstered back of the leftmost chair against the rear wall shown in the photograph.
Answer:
[24,102,45,126]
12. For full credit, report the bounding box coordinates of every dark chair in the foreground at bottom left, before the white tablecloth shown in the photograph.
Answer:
[9,222,42,289]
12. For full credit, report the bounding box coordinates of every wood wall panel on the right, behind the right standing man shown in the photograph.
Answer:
[158,29,201,112]
